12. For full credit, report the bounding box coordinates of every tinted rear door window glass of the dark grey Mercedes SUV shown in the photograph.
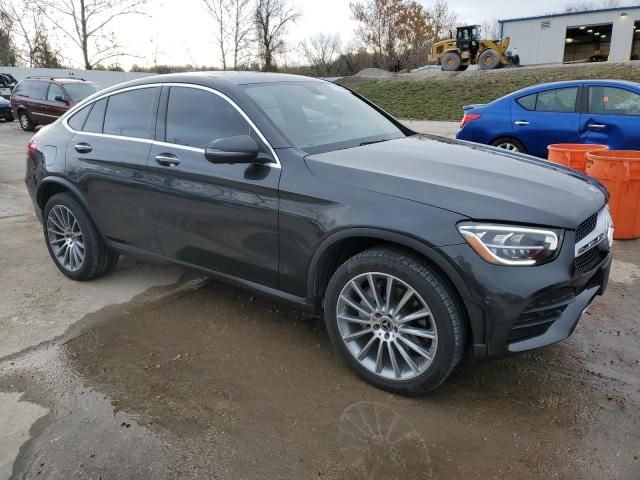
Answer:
[103,87,160,139]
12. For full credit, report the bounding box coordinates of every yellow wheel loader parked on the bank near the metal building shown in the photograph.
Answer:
[431,25,518,72]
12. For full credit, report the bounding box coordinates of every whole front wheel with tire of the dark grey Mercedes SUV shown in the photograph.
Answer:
[324,248,465,395]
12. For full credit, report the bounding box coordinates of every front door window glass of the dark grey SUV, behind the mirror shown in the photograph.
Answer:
[166,87,251,148]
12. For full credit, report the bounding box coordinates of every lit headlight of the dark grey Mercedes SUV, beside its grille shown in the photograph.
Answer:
[458,222,562,266]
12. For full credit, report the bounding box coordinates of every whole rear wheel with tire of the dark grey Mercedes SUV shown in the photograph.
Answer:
[42,193,118,281]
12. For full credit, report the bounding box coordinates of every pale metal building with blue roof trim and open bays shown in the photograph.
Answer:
[499,5,640,65]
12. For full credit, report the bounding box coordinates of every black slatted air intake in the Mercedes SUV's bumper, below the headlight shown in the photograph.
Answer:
[507,288,575,343]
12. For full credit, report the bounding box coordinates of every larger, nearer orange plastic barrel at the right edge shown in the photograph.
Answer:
[587,150,640,240]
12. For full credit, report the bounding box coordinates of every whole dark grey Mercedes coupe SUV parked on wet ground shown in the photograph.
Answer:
[26,73,613,394]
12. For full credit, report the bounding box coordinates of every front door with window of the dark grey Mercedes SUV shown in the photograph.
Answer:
[149,86,280,288]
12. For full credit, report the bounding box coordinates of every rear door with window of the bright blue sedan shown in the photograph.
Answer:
[511,84,580,158]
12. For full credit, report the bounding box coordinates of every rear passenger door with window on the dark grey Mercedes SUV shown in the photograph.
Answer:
[66,87,160,253]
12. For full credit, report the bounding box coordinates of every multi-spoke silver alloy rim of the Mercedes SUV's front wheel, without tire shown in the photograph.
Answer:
[336,272,438,380]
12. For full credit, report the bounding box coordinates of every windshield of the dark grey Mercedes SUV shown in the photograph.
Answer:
[243,82,404,154]
